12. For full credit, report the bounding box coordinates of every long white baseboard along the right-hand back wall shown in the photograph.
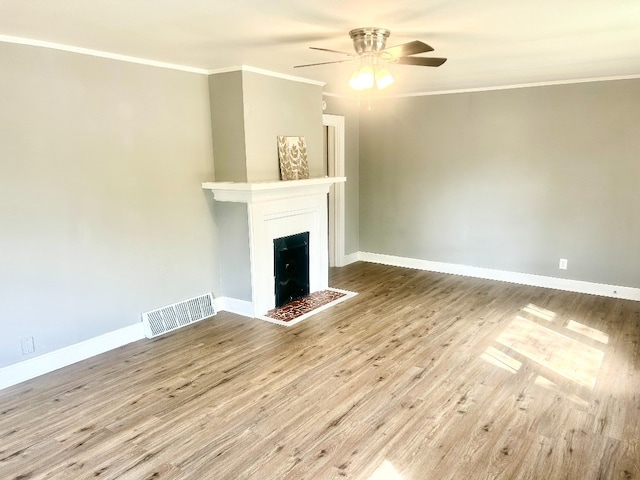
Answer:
[359,252,640,301]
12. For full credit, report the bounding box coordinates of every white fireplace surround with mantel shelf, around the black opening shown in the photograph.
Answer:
[202,177,346,317]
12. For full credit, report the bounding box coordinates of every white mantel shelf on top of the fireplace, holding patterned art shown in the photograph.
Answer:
[202,177,347,203]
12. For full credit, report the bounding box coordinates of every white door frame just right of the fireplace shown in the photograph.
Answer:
[322,114,345,267]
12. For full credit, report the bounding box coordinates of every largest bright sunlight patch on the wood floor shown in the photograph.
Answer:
[496,316,604,388]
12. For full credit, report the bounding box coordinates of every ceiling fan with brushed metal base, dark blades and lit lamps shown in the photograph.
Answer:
[294,27,447,90]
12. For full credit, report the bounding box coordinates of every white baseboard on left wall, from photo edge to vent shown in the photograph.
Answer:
[0,322,145,389]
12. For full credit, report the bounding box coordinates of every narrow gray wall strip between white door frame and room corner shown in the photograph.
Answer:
[324,96,360,254]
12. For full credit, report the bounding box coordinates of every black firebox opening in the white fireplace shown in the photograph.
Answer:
[273,232,309,307]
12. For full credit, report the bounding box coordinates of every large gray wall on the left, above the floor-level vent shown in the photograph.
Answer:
[0,43,219,367]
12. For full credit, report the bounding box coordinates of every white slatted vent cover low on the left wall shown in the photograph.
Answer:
[142,293,216,338]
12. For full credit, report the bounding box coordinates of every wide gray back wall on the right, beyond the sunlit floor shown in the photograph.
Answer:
[360,80,640,287]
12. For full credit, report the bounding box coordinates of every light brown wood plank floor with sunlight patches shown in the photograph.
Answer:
[0,263,640,480]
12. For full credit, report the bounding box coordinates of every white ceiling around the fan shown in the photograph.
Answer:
[0,0,640,94]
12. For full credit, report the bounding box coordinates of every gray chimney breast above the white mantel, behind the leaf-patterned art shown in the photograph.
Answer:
[209,70,325,182]
